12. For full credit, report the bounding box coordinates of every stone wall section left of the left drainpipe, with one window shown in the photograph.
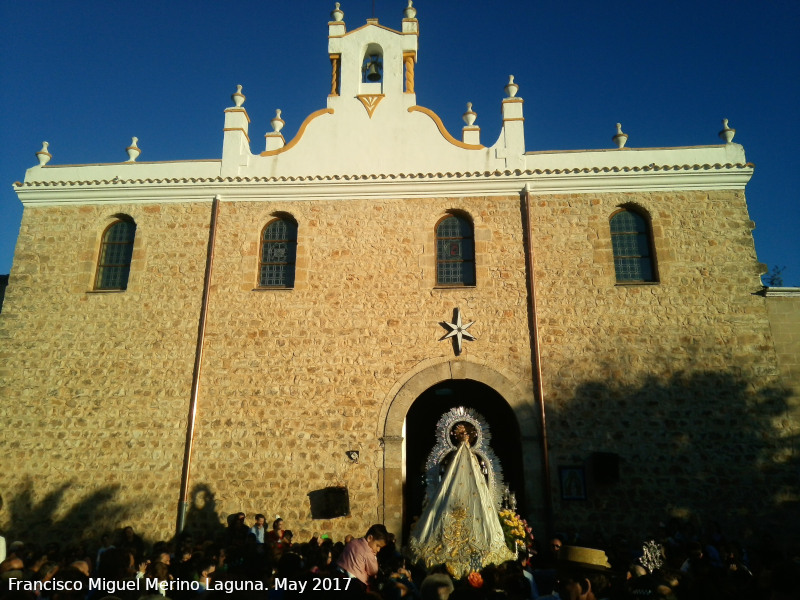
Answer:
[0,202,211,541]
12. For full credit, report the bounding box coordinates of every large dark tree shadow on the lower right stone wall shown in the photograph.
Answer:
[548,369,800,539]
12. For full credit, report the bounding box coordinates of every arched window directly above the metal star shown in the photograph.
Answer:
[436,215,475,286]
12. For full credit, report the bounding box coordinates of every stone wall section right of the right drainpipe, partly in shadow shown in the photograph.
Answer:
[532,191,798,535]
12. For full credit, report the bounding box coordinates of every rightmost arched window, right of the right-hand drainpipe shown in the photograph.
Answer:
[610,209,656,283]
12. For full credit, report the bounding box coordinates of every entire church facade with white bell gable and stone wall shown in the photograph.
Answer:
[0,3,800,539]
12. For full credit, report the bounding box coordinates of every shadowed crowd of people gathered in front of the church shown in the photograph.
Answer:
[0,513,800,600]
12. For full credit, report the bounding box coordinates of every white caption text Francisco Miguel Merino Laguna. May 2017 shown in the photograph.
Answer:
[8,577,350,594]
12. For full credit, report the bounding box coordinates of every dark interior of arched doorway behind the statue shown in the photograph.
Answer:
[403,379,525,540]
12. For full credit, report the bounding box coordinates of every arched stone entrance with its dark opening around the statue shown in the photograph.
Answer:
[379,359,545,541]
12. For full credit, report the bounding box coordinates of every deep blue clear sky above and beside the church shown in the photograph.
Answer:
[0,0,800,286]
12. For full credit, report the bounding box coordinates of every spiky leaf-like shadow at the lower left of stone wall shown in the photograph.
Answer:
[5,478,130,541]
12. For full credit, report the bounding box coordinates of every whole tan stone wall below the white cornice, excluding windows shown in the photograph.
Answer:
[0,191,797,540]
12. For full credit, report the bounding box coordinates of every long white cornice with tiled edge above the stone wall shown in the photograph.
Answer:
[16,163,753,206]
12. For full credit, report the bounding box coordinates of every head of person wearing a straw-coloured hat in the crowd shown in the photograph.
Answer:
[556,546,611,600]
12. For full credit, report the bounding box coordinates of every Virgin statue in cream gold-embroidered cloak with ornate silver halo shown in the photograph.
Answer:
[409,406,514,578]
